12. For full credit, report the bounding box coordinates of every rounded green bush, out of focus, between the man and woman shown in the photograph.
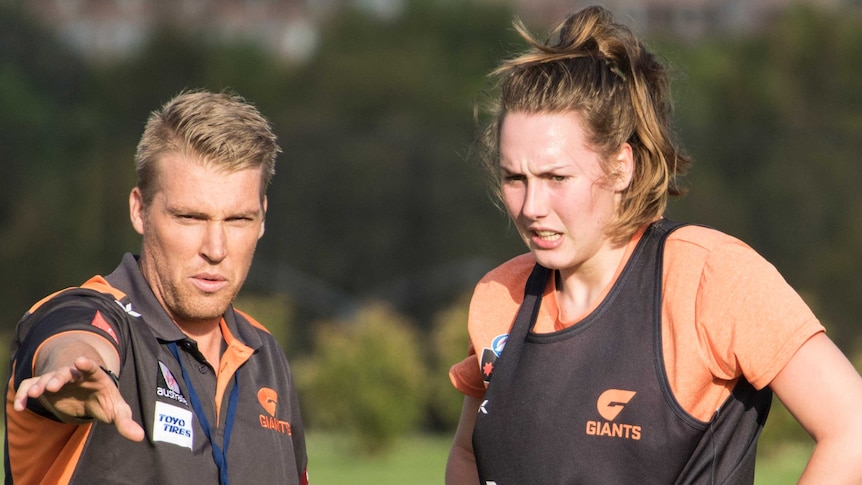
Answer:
[294,303,427,453]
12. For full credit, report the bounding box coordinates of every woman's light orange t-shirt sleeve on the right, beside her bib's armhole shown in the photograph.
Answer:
[662,226,823,421]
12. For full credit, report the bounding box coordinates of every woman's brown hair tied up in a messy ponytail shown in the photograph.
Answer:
[481,7,691,241]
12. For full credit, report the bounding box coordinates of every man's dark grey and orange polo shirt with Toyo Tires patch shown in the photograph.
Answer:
[5,254,308,485]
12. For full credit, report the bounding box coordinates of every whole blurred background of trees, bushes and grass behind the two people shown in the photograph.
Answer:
[0,0,862,484]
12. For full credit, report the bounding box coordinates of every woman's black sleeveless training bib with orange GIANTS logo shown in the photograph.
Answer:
[473,220,771,485]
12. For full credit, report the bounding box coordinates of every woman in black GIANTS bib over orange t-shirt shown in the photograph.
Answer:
[446,7,862,485]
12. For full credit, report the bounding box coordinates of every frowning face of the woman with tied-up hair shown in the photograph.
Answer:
[500,112,631,277]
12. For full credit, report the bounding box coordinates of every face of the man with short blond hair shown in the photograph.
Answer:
[129,153,266,329]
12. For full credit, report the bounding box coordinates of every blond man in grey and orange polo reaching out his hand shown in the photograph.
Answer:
[5,92,307,485]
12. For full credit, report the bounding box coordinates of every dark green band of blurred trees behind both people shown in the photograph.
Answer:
[0,0,862,366]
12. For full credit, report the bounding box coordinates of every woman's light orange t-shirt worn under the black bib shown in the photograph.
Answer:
[449,226,824,421]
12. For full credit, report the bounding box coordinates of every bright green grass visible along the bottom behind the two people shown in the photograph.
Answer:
[307,433,811,485]
